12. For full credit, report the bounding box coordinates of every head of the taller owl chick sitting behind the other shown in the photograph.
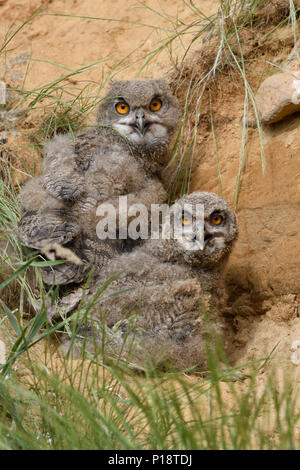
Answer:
[98,80,179,154]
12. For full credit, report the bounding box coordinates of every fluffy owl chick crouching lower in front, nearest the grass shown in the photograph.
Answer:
[64,192,238,370]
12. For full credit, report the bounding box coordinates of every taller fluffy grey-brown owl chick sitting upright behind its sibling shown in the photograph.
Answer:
[18,80,179,284]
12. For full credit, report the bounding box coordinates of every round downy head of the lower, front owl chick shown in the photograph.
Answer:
[166,192,238,267]
